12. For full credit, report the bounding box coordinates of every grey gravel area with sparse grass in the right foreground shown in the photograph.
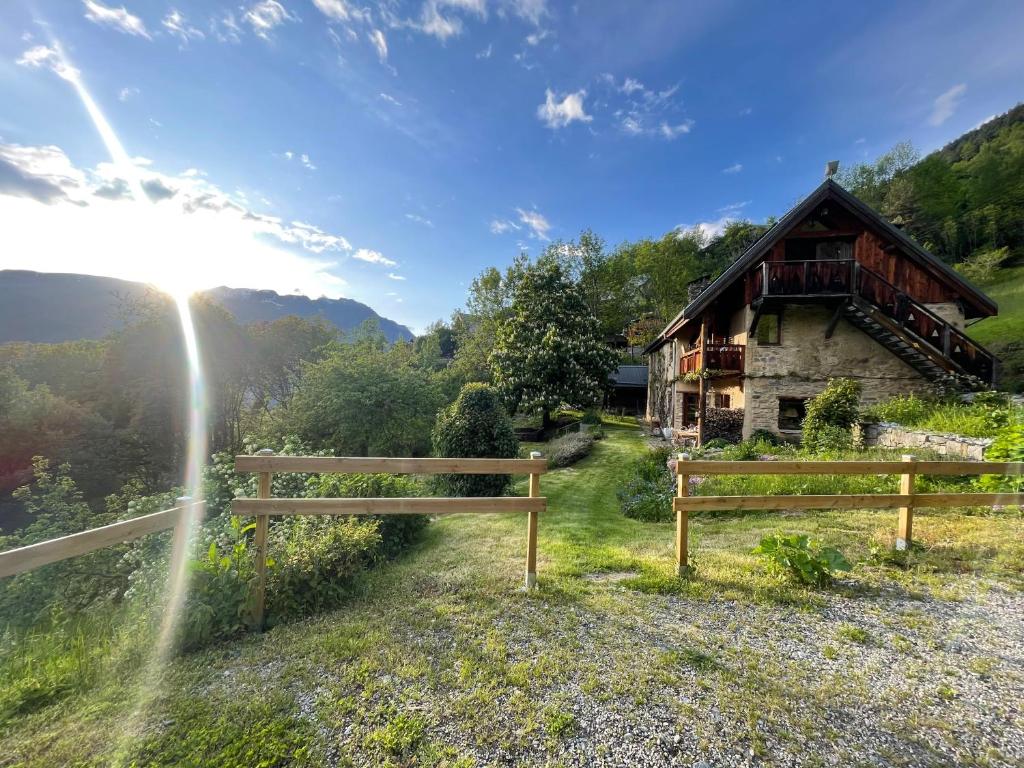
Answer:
[368,580,1024,767]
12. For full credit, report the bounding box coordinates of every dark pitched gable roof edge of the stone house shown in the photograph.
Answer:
[643,178,998,354]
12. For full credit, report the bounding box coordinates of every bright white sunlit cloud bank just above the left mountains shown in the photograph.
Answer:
[0,144,352,297]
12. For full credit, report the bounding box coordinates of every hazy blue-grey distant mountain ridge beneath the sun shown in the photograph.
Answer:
[0,269,413,344]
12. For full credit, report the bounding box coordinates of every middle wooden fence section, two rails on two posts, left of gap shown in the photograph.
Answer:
[231,451,548,627]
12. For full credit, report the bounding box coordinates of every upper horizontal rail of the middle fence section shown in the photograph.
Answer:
[234,456,548,475]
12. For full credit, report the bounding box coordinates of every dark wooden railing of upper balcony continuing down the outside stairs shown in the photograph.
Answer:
[751,259,994,383]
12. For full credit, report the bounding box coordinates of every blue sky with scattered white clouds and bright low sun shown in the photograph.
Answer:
[0,0,1024,330]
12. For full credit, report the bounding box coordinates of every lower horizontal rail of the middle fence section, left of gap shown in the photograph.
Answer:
[231,496,548,515]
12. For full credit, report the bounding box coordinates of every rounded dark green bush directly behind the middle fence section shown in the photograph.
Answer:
[433,383,519,496]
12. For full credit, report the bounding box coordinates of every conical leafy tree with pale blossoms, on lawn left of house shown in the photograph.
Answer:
[489,260,615,427]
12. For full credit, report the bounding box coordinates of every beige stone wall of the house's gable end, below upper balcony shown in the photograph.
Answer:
[743,304,929,437]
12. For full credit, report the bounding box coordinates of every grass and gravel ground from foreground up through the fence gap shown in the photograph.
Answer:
[0,423,1024,766]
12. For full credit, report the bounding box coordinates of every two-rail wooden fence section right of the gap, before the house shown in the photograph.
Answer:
[673,454,1024,575]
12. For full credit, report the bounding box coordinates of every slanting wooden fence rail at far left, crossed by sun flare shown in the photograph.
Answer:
[0,502,203,579]
